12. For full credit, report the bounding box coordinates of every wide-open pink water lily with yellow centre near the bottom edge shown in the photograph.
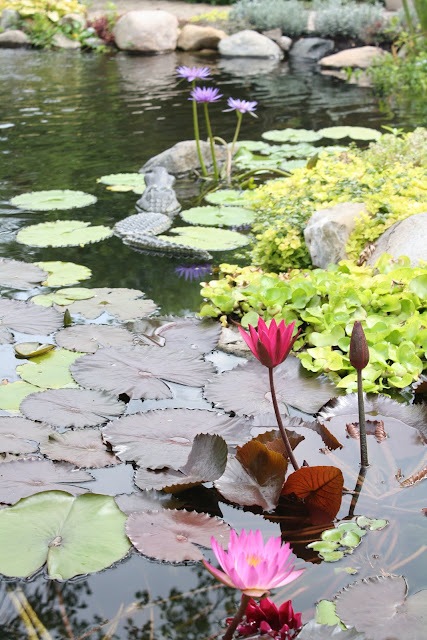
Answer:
[203,529,304,598]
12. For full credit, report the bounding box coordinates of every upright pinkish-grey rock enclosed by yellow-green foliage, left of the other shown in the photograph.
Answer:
[304,202,366,269]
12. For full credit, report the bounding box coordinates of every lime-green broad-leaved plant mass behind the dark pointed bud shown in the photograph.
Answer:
[200,254,427,392]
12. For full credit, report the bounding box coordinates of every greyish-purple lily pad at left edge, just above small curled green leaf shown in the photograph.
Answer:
[0,298,62,335]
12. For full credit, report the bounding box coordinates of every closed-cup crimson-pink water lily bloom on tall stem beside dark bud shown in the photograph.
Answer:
[239,318,299,369]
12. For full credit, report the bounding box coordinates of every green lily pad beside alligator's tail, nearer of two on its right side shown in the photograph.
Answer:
[158,227,249,251]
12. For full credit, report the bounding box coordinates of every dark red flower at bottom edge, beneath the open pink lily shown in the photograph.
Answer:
[227,598,302,640]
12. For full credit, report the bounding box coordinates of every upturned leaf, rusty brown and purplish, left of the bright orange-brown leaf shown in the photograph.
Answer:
[215,440,287,511]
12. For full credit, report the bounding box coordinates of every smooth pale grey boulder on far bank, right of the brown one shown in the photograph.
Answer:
[218,29,283,60]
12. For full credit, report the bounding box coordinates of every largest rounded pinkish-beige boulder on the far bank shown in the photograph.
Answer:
[113,11,178,53]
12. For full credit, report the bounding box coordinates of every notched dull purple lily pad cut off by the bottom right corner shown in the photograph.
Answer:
[335,575,427,640]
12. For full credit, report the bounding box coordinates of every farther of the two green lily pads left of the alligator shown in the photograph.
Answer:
[10,189,97,211]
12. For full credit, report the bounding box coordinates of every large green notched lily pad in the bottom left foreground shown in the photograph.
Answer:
[0,491,130,580]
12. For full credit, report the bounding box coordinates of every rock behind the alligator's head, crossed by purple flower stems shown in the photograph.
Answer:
[139,140,226,176]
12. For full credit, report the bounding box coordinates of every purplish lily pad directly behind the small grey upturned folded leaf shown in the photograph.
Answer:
[102,409,251,469]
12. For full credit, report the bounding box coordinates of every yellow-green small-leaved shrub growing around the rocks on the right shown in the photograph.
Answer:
[244,141,427,271]
